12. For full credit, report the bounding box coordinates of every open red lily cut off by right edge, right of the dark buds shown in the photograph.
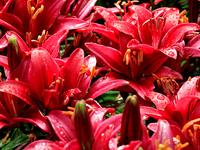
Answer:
[141,77,199,131]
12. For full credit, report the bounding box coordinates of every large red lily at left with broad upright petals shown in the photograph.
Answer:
[1,48,127,112]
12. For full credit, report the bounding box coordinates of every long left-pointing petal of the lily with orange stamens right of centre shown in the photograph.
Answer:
[85,43,131,76]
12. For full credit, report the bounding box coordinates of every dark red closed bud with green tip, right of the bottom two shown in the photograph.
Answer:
[119,95,142,145]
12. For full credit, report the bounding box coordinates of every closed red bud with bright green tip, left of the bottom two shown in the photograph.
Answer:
[74,100,94,150]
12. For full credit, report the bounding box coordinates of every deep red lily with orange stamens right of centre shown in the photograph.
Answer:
[86,43,179,98]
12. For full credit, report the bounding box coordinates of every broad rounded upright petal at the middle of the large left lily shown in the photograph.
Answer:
[29,47,60,96]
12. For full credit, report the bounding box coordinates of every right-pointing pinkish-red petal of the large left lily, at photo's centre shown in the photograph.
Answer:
[84,73,129,99]
